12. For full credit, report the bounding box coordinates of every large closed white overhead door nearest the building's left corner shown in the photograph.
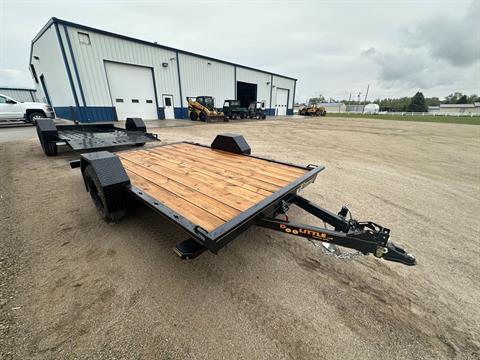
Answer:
[105,62,158,120]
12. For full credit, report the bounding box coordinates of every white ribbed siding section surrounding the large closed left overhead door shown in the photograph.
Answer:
[64,27,180,107]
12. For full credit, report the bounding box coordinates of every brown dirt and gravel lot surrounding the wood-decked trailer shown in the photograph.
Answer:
[0,118,480,359]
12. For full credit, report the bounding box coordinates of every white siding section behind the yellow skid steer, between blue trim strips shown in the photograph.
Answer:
[178,53,235,108]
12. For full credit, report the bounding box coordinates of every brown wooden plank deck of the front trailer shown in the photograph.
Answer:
[117,143,309,232]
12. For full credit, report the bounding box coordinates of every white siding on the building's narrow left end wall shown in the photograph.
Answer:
[32,26,75,106]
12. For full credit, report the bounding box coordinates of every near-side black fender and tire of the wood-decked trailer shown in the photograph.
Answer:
[80,151,130,221]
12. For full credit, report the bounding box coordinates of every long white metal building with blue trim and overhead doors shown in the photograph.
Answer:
[30,18,296,122]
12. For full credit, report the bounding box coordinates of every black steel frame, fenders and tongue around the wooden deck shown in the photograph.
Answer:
[71,134,416,266]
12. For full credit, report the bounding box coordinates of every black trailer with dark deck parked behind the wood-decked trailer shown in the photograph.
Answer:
[37,118,158,156]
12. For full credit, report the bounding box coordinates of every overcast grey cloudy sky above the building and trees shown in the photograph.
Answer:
[0,0,480,101]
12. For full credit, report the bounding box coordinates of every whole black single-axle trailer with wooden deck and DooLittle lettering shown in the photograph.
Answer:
[71,134,415,265]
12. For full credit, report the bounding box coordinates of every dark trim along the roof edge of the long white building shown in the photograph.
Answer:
[30,17,297,81]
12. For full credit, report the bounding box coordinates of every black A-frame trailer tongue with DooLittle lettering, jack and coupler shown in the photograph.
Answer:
[256,195,416,266]
